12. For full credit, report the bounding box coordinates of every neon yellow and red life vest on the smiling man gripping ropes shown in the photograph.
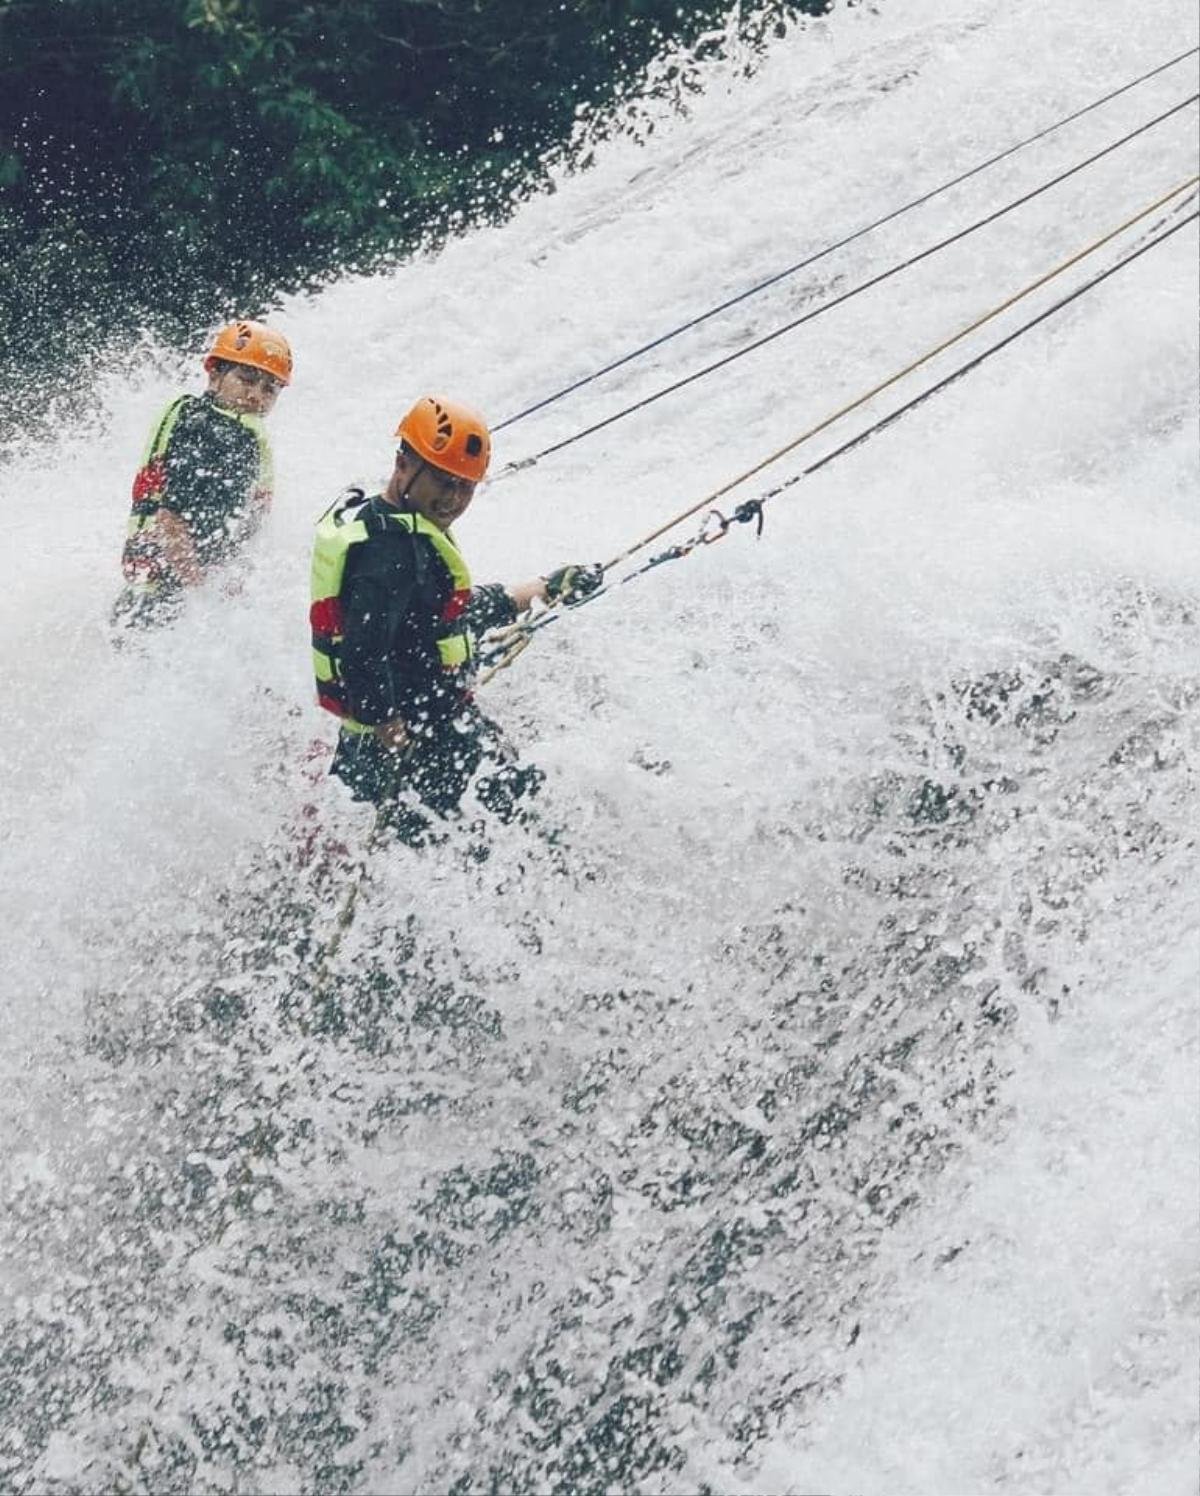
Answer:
[308,497,474,733]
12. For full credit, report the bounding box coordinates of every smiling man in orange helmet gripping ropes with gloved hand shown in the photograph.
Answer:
[310,395,603,844]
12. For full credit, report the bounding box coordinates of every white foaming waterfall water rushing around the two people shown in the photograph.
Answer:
[0,0,1200,1496]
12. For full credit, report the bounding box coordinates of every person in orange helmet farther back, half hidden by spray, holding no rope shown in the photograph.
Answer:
[114,319,292,625]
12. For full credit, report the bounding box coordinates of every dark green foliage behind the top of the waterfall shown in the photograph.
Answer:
[0,0,832,442]
